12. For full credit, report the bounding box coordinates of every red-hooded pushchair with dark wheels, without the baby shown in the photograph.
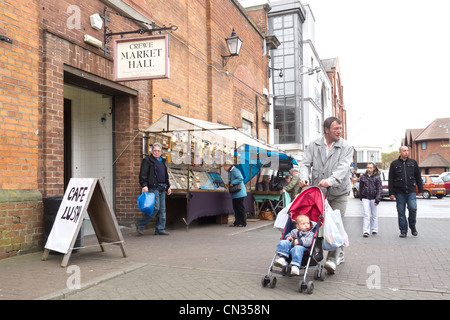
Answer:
[261,187,325,294]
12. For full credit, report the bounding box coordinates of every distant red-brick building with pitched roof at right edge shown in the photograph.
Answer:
[402,118,450,174]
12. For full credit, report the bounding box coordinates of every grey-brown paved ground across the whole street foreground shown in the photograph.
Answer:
[0,195,450,302]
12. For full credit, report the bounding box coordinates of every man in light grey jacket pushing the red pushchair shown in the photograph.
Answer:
[299,117,353,274]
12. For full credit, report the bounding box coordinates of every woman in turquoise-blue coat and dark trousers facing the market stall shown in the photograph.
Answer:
[223,160,247,227]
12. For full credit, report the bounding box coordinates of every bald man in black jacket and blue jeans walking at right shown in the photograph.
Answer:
[389,146,423,238]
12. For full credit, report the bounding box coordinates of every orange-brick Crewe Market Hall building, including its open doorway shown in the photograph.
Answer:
[0,0,268,258]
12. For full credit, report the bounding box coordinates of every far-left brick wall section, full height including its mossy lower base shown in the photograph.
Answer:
[0,0,42,259]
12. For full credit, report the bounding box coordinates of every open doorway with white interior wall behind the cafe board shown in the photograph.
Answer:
[64,84,114,203]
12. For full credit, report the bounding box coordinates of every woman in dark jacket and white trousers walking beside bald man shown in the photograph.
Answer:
[359,162,382,237]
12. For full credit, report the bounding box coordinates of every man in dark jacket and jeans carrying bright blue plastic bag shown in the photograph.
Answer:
[136,142,172,235]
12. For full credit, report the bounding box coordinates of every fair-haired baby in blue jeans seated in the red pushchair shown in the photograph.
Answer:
[274,214,317,276]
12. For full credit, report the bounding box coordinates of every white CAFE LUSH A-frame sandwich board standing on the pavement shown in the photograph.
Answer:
[42,178,127,267]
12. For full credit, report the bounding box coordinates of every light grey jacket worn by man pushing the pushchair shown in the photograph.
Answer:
[300,136,353,196]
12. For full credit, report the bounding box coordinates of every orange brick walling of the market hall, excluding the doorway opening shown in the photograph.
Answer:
[0,0,268,254]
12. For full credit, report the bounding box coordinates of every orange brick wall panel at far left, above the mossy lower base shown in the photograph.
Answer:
[0,0,39,190]
